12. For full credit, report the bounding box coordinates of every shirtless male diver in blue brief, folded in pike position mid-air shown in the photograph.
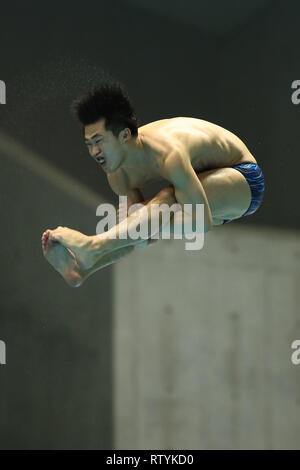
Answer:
[42,80,264,287]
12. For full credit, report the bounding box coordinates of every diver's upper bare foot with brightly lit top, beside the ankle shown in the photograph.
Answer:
[47,227,95,270]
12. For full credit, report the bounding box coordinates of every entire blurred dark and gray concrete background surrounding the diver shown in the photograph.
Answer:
[0,0,300,449]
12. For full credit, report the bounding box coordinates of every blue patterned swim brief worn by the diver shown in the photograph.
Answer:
[223,163,265,224]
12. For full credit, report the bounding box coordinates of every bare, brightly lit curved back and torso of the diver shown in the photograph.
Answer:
[109,117,256,193]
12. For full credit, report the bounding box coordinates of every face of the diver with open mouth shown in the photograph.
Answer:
[84,119,122,173]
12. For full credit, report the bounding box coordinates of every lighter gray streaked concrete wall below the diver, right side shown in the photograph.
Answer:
[114,219,300,449]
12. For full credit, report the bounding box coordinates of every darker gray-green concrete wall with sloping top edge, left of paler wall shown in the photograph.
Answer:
[0,136,112,449]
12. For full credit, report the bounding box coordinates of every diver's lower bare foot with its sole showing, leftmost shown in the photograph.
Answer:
[42,230,84,287]
